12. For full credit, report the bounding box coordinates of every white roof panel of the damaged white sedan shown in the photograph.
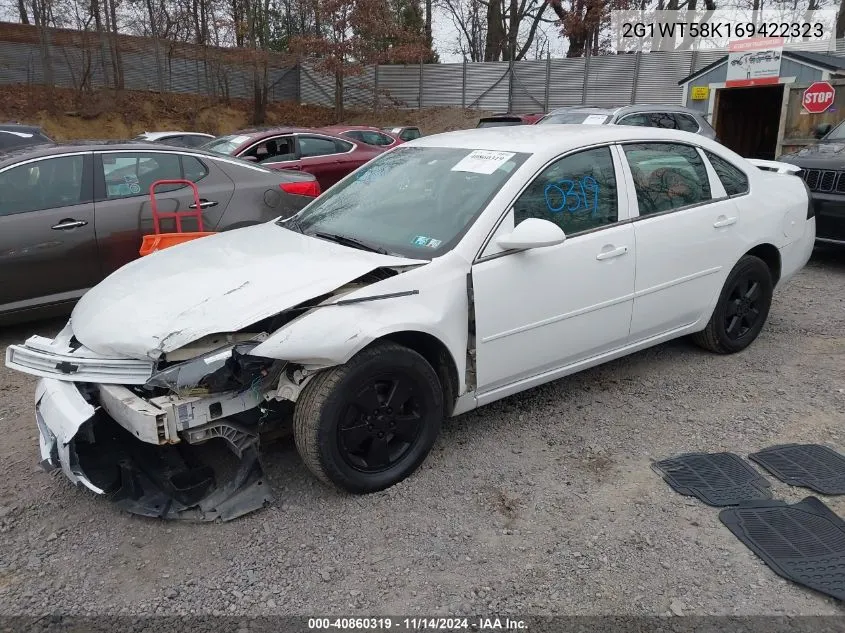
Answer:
[408,125,718,159]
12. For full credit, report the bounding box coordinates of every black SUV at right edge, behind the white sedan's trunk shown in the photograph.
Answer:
[778,121,845,245]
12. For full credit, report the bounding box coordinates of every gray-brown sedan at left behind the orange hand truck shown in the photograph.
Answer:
[0,142,319,325]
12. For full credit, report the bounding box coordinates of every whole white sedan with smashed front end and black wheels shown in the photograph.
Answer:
[6,126,815,519]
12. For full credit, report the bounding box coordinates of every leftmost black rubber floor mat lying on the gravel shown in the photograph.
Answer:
[653,453,772,507]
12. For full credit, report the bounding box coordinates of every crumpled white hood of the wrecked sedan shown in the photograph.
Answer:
[71,223,423,359]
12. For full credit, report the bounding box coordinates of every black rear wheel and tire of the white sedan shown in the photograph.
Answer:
[692,255,774,354]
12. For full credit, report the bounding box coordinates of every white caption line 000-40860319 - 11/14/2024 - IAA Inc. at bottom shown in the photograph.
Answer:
[308,617,528,633]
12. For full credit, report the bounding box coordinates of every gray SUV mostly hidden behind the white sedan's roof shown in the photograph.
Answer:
[536,105,718,140]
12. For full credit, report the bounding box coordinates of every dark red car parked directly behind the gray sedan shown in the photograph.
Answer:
[202,127,385,191]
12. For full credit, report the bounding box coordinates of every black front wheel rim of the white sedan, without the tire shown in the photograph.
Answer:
[338,374,424,473]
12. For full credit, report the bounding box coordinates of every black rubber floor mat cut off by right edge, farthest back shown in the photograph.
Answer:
[748,444,845,495]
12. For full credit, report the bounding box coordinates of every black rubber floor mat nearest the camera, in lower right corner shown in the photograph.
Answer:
[719,497,845,600]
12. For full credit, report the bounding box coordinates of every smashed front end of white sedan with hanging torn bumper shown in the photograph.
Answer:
[15,334,290,521]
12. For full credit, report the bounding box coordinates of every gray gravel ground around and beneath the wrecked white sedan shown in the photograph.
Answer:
[0,251,845,615]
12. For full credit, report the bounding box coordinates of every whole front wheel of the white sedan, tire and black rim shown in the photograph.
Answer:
[293,342,443,494]
